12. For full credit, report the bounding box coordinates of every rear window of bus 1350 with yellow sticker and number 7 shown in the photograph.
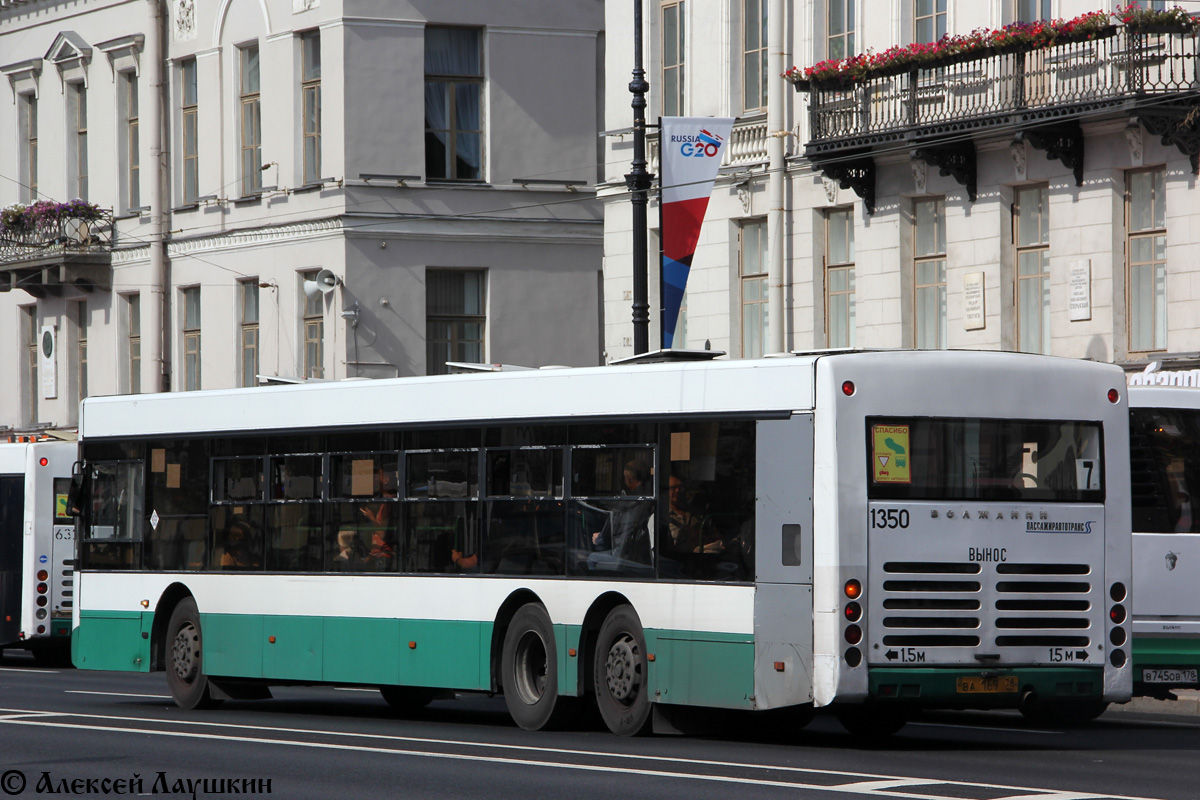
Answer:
[866,417,1104,503]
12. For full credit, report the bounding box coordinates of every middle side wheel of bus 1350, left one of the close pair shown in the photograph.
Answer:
[500,603,566,730]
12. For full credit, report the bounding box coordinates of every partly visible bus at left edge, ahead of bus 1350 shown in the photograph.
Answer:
[0,441,76,660]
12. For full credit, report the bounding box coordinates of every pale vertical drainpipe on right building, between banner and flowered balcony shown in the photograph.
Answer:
[763,0,788,353]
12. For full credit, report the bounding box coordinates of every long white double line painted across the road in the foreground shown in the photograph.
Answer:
[0,709,1171,800]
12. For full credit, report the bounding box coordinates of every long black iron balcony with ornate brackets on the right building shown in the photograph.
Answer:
[793,25,1200,207]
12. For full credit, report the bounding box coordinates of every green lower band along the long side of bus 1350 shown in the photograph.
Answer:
[72,612,755,709]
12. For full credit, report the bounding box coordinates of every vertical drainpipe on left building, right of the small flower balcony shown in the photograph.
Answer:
[142,0,170,392]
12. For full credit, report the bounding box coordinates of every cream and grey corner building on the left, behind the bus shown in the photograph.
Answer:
[0,0,604,434]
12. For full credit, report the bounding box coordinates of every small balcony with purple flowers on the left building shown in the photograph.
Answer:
[0,200,114,297]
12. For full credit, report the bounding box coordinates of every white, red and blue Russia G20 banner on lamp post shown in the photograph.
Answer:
[659,116,733,348]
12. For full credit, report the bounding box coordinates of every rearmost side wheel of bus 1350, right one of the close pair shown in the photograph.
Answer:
[592,606,652,736]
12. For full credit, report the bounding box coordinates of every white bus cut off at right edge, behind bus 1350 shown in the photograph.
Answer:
[1129,386,1200,699]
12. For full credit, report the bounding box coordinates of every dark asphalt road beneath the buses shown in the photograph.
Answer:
[0,651,1200,800]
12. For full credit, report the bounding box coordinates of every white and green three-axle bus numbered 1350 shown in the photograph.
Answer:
[73,351,1132,734]
